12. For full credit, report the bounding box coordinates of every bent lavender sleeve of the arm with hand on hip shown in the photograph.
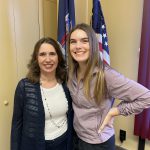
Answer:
[105,67,150,116]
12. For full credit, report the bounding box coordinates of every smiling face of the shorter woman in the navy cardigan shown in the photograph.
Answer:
[38,43,58,74]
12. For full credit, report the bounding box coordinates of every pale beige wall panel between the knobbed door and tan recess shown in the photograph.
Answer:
[13,0,40,79]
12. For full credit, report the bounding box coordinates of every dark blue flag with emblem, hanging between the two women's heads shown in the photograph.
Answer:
[57,0,75,57]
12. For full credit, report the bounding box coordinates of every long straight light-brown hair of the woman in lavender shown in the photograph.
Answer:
[67,23,107,105]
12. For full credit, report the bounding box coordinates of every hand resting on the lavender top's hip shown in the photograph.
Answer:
[98,107,120,133]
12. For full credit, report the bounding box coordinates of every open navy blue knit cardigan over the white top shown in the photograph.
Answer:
[11,78,73,150]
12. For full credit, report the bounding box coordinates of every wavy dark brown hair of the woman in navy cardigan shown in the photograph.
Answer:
[27,37,67,83]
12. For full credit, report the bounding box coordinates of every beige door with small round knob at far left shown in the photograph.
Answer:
[0,0,15,150]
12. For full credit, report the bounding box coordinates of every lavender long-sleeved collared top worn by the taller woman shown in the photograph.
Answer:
[68,67,150,144]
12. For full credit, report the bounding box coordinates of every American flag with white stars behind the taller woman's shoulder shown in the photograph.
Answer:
[92,0,110,65]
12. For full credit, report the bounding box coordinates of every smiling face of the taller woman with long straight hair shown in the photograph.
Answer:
[70,29,90,64]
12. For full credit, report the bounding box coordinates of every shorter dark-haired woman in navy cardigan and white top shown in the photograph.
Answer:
[11,38,73,150]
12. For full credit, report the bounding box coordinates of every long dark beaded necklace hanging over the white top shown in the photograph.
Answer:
[41,86,67,128]
